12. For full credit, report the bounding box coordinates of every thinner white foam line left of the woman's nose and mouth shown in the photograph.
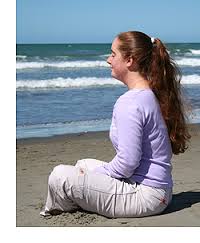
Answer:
[16,61,109,69]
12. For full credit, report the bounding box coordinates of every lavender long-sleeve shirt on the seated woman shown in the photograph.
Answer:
[95,89,173,188]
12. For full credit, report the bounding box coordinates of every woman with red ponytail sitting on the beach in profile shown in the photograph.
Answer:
[41,31,190,217]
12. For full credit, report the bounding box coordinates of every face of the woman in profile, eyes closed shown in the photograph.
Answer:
[107,38,127,82]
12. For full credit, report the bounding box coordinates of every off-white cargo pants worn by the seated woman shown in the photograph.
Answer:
[40,159,172,218]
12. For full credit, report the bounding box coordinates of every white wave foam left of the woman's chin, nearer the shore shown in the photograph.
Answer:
[16,77,122,90]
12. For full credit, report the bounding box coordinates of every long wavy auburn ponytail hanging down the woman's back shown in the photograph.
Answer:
[148,39,191,154]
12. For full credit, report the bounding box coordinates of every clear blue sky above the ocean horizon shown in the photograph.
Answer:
[16,0,200,43]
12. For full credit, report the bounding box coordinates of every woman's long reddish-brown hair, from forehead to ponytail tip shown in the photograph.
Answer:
[117,31,191,154]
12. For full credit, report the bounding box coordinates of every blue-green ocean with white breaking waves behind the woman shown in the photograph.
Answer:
[16,43,200,139]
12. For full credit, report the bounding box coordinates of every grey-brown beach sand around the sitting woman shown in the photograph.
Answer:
[16,125,200,227]
